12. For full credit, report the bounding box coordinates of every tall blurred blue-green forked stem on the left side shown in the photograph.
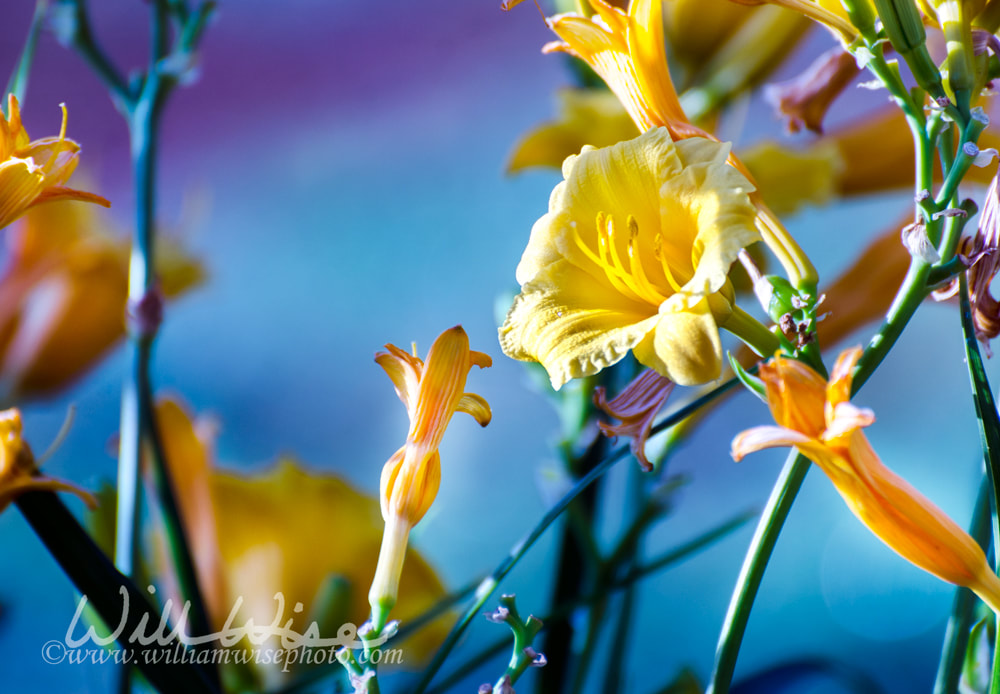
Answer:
[62,0,217,684]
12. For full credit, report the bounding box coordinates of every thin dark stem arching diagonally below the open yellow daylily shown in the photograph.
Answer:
[413,378,739,694]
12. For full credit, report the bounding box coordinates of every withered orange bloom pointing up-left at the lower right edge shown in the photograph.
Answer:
[733,347,1000,612]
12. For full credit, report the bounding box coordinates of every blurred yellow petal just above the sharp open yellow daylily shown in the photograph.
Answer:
[507,88,640,173]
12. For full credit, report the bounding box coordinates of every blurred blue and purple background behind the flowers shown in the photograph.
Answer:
[0,0,997,693]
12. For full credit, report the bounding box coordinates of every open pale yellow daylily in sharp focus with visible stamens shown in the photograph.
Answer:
[500,128,760,389]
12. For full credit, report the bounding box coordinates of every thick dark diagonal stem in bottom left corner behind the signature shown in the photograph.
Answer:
[15,492,218,694]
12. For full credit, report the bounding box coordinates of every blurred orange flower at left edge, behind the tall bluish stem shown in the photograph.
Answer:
[0,202,202,401]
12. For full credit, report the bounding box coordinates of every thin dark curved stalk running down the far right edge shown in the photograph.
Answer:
[958,272,1000,694]
